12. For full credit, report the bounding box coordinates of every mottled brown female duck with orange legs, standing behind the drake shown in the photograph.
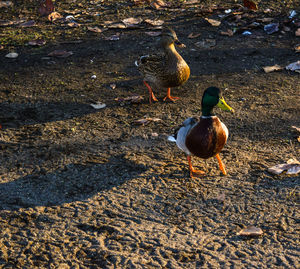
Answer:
[135,28,190,104]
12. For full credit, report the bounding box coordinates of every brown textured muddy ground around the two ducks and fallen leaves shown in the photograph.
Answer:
[0,1,300,268]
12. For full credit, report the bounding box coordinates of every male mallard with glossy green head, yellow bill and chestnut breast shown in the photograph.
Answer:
[169,87,234,177]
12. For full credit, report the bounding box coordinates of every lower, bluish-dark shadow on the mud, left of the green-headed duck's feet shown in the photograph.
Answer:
[0,155,146,210]
